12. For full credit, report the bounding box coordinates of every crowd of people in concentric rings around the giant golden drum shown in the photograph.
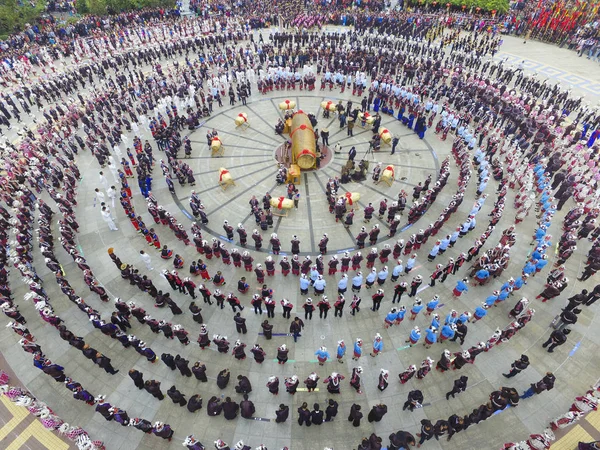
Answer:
[0,2,600,450]
